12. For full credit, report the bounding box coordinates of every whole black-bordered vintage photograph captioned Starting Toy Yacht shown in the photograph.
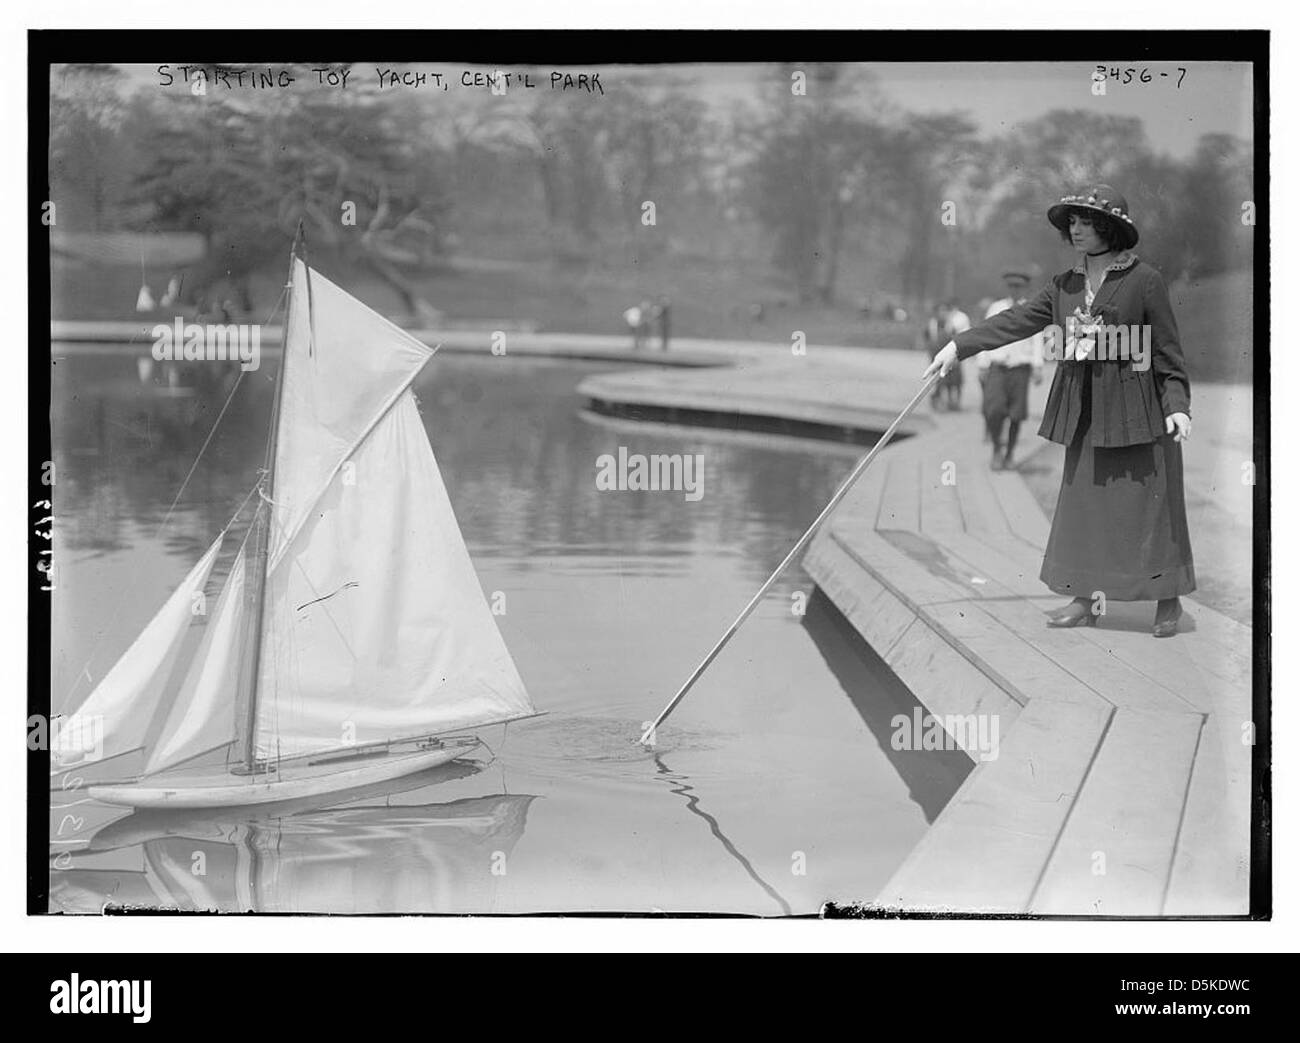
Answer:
[27,33,1270,918]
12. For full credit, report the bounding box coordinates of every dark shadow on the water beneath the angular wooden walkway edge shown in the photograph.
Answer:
[803,588,975,822]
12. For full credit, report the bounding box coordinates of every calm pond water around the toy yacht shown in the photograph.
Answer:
[51,346,970,916]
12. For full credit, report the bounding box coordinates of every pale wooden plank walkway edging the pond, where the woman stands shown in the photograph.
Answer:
[581,353,1252,917]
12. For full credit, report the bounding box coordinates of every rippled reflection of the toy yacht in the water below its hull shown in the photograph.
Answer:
[51,762,536,913]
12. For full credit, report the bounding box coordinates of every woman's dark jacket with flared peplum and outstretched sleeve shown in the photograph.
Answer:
[953,254,1191,449]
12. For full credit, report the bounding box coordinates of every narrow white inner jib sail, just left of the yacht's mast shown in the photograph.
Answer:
[144,549,247,775]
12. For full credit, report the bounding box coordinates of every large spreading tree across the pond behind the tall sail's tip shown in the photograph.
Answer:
[126,61,450,311]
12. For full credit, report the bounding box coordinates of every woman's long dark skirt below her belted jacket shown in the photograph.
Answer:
[1040,379,1196,601]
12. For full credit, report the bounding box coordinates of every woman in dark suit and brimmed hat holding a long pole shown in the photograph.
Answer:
[926,185,1196,637]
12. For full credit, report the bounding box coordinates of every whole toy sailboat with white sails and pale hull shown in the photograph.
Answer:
[53,239,536,808]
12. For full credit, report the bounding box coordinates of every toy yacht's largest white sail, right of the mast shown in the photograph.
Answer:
[256,263,533,757]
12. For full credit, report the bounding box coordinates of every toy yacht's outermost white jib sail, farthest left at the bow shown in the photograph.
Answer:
[52,533,225,763]
